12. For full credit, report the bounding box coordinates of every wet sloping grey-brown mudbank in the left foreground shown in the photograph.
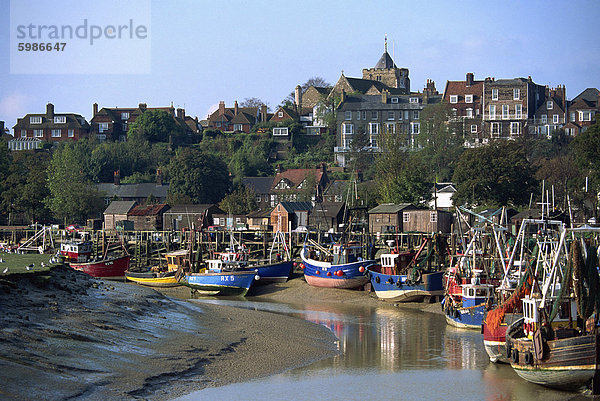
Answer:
[0,267,338,400]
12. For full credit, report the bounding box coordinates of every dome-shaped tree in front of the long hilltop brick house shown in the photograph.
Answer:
[127,110,187,144]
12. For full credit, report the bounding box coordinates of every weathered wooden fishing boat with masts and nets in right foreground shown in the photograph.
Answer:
[506,227,600,391]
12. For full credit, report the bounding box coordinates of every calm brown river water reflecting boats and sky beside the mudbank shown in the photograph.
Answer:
[178,299,587,401]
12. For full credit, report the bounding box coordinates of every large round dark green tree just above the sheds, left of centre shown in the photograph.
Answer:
[168,148,230,203]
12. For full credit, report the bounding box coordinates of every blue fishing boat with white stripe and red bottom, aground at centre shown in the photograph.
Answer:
[300,241,376,288]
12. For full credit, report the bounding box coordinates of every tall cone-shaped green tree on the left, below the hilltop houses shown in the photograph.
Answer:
[46,143,103,223]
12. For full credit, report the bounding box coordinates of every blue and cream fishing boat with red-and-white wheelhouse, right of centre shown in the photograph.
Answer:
[368,238,444,302]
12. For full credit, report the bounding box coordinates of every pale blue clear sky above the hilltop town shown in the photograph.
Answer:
[0,0,600,133]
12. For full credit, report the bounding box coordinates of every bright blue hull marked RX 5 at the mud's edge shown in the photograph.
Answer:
[182,270,256,296]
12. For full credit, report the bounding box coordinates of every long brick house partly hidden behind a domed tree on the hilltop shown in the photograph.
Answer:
[90,103,196,142]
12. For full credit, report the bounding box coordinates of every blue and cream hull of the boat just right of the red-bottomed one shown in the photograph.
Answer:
[369,270,444,302]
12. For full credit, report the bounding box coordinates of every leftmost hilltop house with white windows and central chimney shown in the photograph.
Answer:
[13,103,90,142]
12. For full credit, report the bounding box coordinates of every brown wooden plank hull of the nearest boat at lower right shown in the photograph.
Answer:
[506,323,597,390]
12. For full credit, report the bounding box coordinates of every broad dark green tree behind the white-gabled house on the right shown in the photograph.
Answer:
[452,141,536,207]
